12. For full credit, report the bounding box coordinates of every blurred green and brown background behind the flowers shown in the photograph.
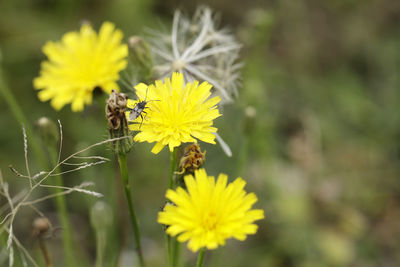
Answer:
[0,0,400,267]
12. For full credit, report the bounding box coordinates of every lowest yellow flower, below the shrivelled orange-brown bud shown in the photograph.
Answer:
[158,169,264,252]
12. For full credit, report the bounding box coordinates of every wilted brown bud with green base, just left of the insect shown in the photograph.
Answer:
[106,90,133,154]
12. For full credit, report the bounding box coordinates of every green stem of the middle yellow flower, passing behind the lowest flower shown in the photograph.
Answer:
[167,148,180,267]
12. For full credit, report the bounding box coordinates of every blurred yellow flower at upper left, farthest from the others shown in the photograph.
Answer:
[33,22,128,111]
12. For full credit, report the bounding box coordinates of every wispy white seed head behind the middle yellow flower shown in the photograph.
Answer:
[148,7,241,104]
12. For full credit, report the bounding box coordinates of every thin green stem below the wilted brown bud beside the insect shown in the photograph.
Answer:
[118,154,144,266]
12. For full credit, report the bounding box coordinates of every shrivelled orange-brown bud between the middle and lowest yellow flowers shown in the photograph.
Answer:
[177,143,206,174]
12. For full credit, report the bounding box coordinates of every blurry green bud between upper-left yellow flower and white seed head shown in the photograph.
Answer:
[128,36,153,82]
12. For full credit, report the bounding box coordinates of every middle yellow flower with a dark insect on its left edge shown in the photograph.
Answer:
[127,72,221,154]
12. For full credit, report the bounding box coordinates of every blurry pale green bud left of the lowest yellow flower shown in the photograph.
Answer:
[90,201,113,231]
